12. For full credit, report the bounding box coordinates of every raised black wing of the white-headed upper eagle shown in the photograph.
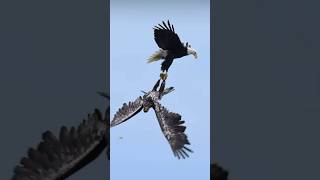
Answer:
[153,20,185,50]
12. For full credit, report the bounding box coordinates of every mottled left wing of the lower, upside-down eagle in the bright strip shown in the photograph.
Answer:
[110,96,143,127]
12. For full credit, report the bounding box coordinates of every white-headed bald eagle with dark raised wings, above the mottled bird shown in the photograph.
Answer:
[147,20,198,80]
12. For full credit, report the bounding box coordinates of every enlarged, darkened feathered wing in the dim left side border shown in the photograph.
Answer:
[12,93,110,180]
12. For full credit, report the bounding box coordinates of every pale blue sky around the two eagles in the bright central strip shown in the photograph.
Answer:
[110,0,210,180]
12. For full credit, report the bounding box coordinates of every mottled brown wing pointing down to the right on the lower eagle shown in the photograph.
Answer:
[154,102,192,159]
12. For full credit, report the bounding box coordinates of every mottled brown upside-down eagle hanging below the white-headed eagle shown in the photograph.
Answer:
[110,79,192,159]
